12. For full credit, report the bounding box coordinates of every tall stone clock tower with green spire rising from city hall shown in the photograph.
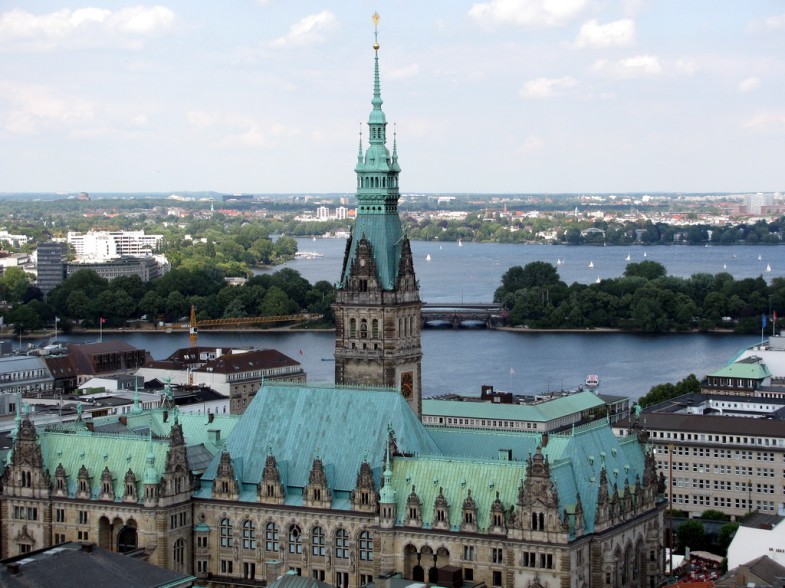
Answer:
[333,14,422,417]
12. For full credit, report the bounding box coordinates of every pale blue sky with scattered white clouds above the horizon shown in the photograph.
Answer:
[0,0,785,194]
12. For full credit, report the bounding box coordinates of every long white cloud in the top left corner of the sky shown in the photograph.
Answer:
[0,5,175,50]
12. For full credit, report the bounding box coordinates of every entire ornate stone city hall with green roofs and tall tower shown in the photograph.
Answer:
[0,20,665,588]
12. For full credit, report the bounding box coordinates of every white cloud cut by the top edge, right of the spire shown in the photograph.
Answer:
[469,0,586,27]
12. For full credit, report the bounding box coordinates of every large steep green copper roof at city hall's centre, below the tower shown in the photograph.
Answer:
[202,383,438,492]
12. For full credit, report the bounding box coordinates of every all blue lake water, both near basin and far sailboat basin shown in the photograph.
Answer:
[49,239,764,398]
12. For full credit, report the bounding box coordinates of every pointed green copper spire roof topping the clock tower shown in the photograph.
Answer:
[339,34,403,290]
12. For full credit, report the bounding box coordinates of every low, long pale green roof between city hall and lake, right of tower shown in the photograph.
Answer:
[422,392,605,422]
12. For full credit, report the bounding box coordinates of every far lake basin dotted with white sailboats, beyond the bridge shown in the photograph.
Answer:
[264,239,785,303]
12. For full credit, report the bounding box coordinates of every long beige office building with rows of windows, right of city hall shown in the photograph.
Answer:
[614,394,785,518]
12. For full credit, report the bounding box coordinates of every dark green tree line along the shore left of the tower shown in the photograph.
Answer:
[0,266,335,332]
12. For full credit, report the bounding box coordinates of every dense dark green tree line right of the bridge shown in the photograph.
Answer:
[494,261,785,333]
